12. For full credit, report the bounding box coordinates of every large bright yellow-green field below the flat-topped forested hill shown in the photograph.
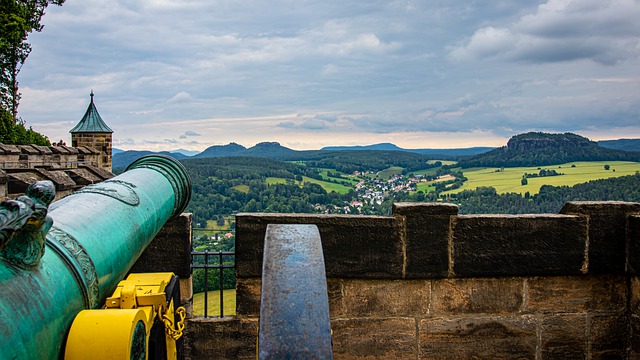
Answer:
[445,161,640,195]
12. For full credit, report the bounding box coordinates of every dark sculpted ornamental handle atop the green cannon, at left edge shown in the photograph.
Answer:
[0,180,56,268]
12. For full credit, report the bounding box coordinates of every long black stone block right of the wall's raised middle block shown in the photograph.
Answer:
[453,215,587,277]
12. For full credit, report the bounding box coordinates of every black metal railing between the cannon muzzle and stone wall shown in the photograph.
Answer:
[191,251,236,317]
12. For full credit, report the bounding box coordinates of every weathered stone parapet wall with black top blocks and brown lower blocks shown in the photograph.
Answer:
[185,202,640,359]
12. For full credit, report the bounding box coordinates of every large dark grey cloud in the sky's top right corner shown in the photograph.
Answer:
[449,0,640,65]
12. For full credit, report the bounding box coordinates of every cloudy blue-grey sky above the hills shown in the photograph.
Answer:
[13,0,640,151]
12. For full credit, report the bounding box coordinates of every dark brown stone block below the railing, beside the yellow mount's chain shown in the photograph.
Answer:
[185,318,258,360]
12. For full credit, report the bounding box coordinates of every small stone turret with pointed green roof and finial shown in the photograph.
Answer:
[69,90,113,171]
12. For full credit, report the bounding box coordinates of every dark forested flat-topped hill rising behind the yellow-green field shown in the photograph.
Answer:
[460,132,640,168]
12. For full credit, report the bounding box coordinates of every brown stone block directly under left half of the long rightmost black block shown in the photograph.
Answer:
[432,278,523,316]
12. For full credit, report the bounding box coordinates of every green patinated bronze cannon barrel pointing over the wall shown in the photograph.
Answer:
[0,155,191,359]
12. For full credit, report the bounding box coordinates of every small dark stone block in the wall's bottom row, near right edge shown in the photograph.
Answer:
[589,313,628,359]
